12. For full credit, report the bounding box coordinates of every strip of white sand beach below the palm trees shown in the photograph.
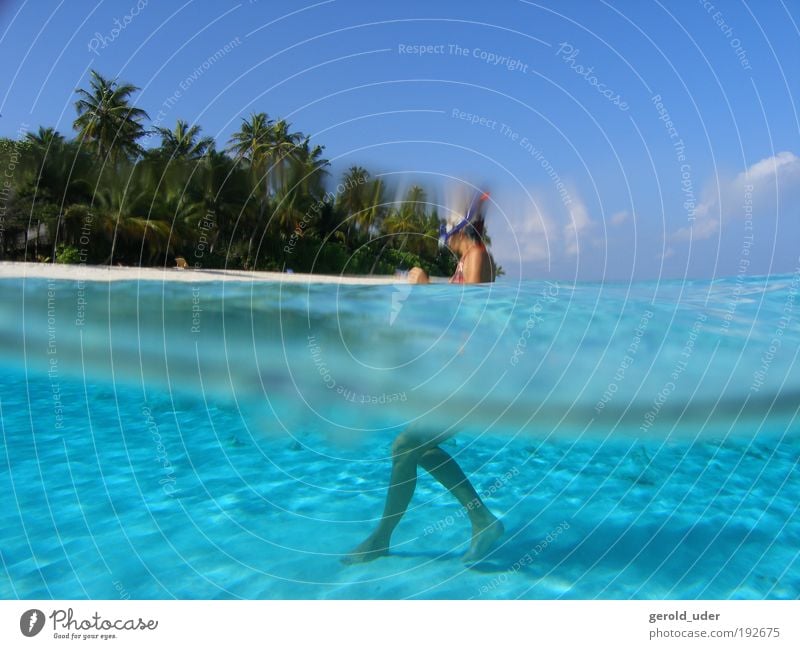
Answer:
[0,262,406,284]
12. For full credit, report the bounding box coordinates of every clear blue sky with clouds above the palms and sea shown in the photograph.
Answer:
[0,0,800,281]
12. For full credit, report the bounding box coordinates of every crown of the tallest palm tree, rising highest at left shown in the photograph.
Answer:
[73,70,149,164]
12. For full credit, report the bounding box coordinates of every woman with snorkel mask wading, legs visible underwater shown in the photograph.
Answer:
[344,194,504,563]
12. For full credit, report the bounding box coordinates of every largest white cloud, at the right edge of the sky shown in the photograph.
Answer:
[670,151,800,242]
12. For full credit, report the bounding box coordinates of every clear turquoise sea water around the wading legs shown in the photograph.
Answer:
[0,275,800,599]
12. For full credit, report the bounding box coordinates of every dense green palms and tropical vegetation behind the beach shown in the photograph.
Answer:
[0,71,500,275]
